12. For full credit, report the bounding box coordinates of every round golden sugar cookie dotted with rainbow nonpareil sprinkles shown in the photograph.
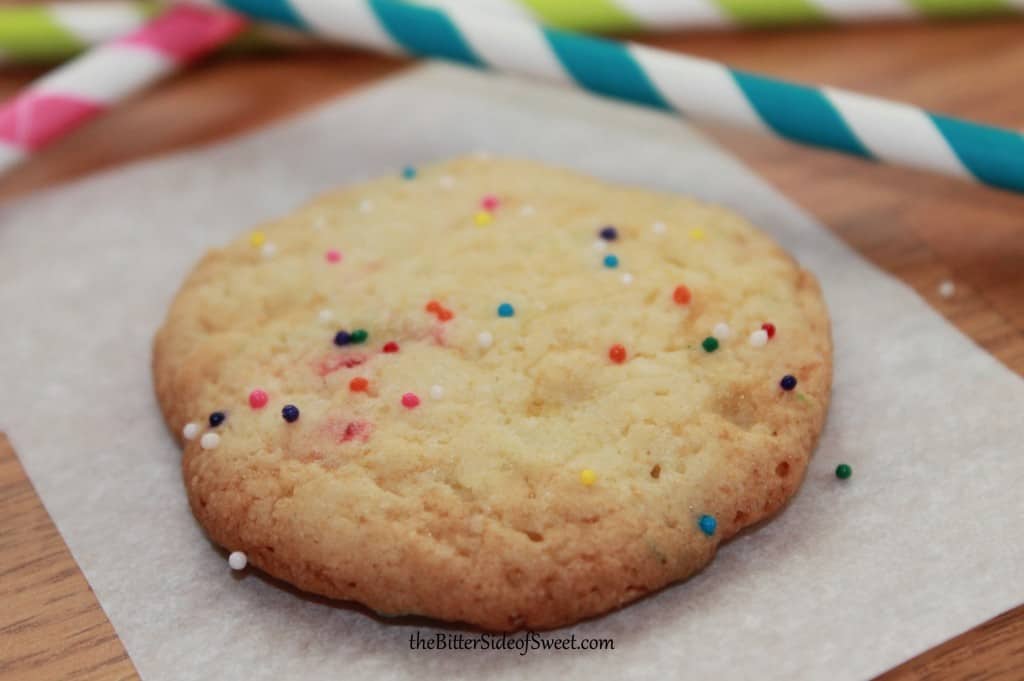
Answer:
[153,159,831,631]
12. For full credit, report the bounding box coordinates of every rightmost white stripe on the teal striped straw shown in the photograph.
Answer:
[822,88,972,178]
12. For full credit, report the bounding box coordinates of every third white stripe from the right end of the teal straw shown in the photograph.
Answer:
[449,6,572,84]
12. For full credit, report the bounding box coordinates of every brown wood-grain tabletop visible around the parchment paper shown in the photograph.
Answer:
[0,13,1024,681]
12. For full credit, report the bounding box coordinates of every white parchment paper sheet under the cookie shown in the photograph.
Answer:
[0,67,1024,681]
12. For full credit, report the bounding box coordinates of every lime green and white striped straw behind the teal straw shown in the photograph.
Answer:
[0,0,1024,62]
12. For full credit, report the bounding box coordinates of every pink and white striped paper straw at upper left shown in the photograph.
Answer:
[0,5,247,173]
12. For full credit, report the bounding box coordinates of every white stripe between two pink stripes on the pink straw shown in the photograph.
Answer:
[31,44,175,104]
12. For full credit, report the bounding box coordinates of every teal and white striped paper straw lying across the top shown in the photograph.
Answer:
[201,0,1024,191]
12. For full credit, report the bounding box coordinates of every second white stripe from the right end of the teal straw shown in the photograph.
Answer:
[629,45,770,132]
